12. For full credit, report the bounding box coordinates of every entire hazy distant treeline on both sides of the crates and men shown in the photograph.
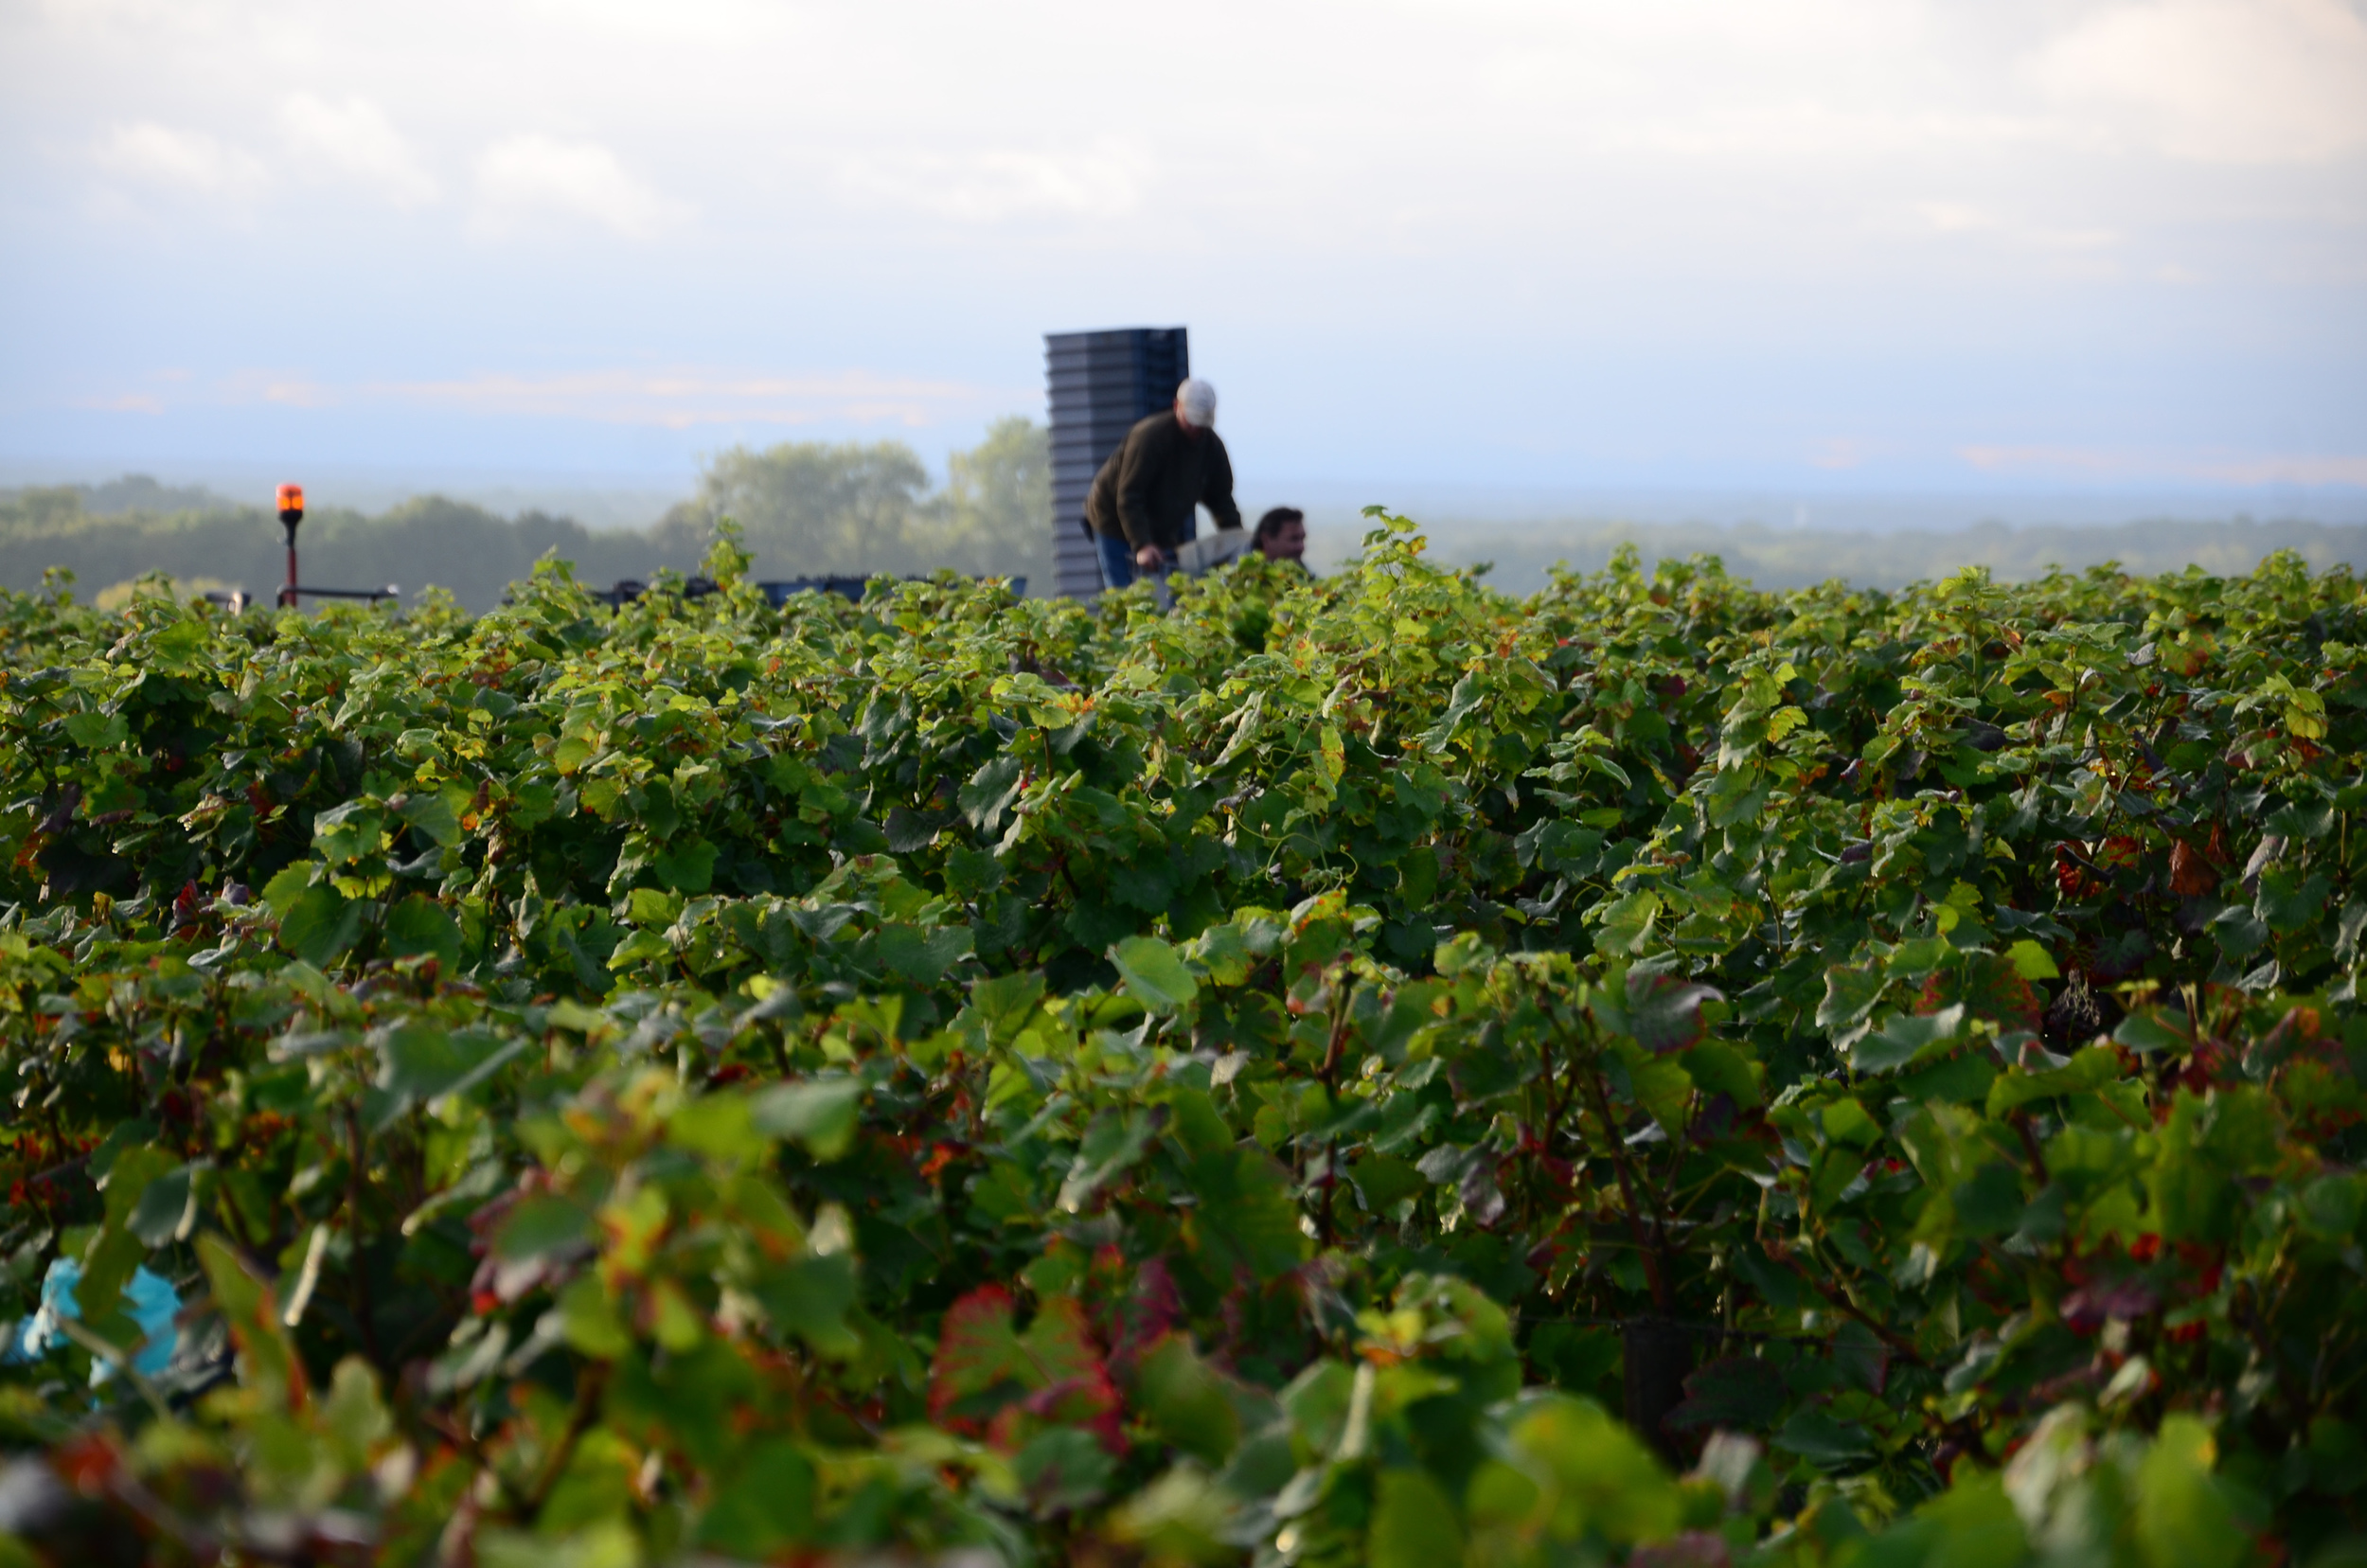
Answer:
[0,442,2367,611]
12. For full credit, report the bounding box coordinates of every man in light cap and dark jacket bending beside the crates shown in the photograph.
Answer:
[1084,377,1240,587]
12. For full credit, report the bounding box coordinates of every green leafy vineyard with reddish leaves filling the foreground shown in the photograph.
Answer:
[0,516,2367,1568]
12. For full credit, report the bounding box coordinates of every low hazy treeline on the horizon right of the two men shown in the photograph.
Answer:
[1373,516,2367,595]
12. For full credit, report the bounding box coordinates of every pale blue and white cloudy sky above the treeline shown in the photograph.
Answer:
[0,0,2367,504]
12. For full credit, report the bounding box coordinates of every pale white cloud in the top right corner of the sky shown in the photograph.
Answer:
[2029,0,2367,164]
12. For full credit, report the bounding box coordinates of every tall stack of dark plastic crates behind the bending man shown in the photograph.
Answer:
[1044,327,1191,599]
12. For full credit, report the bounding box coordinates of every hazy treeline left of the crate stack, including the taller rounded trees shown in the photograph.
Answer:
[0,419,1051,611]
